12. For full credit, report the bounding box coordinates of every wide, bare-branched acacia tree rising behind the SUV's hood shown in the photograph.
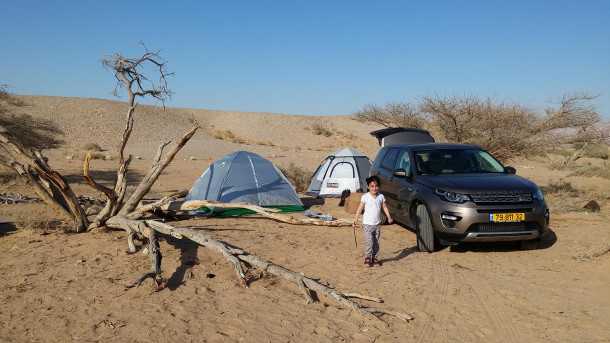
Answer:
[420,94,601,159]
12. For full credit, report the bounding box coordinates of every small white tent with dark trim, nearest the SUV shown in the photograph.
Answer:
[307,148,371,197]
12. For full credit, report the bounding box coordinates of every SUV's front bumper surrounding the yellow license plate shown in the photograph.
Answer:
[429,201,549,243]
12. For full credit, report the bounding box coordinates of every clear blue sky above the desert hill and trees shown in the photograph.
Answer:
[0,0,610,118]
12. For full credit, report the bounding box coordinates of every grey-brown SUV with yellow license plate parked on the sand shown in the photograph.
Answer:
[371,143,549,252]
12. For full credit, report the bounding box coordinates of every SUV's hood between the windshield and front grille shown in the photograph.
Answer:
[416,174,536,194]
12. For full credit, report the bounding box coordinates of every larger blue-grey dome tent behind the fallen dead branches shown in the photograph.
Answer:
[186,151,303,215]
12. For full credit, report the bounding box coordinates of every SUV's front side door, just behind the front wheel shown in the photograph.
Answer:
[391,149,415,223]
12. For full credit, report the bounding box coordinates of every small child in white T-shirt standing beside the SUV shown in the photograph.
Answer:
[353,176,394,267]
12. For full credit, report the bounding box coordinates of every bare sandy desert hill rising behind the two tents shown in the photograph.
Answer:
[18,96,378,168]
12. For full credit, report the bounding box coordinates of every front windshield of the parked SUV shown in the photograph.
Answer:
[415,149,504,175]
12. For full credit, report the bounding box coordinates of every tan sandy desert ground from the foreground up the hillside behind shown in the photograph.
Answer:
[0,97,610,342]
